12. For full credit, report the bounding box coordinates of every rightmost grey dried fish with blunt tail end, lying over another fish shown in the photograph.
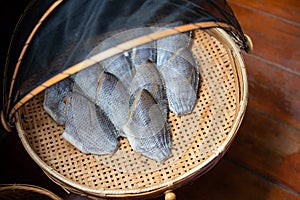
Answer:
[158,48,199,115]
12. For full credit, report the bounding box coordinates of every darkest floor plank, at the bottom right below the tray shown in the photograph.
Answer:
[155,159,300,200]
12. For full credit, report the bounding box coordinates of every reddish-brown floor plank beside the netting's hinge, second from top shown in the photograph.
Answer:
[231,4,300,73]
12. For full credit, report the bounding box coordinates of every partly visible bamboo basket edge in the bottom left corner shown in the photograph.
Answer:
[0,184,62,200]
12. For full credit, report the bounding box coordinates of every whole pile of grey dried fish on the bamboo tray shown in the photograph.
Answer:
[44,25,199,162]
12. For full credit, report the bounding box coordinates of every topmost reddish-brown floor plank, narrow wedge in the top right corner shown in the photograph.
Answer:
[228,0,300,23]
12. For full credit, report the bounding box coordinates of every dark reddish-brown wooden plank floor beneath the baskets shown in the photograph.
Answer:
[0,0,300,200]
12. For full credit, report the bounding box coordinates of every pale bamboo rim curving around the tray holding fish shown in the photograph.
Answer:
[16,28,248,197]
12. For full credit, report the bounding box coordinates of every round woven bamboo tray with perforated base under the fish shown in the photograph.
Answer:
[16,28,248,199]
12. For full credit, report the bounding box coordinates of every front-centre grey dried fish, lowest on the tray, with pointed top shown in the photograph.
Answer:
[123,89,171,162]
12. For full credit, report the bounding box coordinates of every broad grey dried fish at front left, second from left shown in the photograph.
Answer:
[62,92,119,155]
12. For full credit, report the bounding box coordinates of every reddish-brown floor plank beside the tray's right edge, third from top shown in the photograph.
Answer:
[244,55,300,129]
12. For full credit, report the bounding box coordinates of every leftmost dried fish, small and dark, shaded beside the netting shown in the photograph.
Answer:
[43,78,72,125]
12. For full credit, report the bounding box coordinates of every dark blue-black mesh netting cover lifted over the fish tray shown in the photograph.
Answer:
[3,0,248,122]
